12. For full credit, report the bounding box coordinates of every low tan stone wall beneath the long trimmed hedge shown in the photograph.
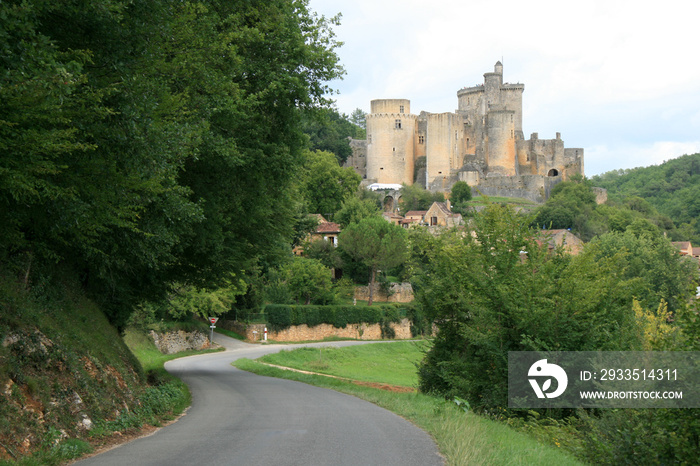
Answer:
[234,319,412,342]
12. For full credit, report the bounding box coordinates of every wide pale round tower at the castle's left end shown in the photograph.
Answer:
[367,99,417,185]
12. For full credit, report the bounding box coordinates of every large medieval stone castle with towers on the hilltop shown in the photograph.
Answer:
[346,61,583,202]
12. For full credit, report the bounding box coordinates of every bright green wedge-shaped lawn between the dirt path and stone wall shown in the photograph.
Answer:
[260,341,429,387]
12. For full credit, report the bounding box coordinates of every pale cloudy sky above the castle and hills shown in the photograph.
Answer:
[309,0,700,177]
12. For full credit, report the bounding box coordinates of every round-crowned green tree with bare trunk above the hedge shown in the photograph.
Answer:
[338,216,408,305]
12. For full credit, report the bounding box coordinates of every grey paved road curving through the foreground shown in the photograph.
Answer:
[77,334,443,466]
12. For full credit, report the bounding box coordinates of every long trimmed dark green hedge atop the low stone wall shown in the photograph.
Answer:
[265,304,413,331]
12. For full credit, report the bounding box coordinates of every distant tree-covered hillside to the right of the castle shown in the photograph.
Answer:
[591,154,700,242]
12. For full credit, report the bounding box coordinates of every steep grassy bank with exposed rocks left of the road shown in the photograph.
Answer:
[0,275,156,464]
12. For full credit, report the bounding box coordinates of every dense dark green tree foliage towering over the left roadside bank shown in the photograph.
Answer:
[0,0,342,325]
